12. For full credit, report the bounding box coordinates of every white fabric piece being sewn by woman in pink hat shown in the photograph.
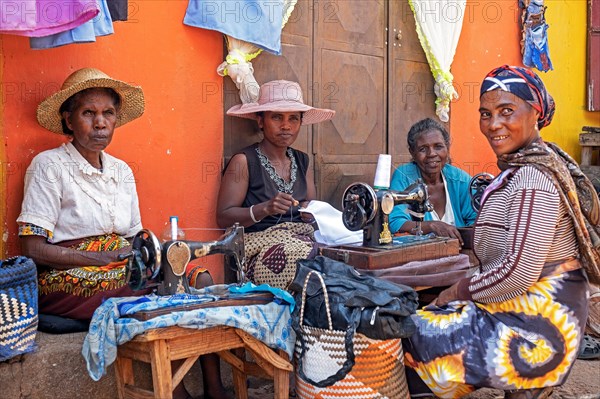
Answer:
[299,200,363,245]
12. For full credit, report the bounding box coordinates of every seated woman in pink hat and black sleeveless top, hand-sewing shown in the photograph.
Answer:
[217,80,335,288]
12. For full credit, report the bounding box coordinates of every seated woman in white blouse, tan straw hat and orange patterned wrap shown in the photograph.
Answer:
[17,68,228,398]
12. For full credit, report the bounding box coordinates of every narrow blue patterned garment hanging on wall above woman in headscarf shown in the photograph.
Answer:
[519,0,553,72]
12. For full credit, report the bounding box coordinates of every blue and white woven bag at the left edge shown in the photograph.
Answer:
[0,256,38,362]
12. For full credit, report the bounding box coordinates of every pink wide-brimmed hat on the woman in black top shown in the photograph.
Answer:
[227,80,335,125]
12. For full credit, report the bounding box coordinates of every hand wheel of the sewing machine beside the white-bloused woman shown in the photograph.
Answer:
[126,229,161,290]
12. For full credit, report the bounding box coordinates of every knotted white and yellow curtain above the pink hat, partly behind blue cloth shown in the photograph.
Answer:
[217,0,298,104]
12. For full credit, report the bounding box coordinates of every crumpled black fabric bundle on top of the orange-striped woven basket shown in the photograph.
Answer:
[289,256,418,340]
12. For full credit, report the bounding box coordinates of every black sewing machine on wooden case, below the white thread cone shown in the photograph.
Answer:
[342,179,433,247]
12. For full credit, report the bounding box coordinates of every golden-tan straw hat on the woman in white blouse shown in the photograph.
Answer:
[37,68,144,134]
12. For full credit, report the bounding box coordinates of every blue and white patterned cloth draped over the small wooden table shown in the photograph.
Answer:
[82,285,296,381]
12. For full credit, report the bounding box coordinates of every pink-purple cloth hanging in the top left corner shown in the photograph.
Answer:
[0,0,100,37]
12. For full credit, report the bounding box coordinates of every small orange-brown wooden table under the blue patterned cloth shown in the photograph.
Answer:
[115,326,293,399]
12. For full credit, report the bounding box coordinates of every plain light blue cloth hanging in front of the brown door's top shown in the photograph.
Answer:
[183,0,284,55]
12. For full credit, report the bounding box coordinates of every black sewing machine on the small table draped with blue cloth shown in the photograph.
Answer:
[120,223,245,295]
